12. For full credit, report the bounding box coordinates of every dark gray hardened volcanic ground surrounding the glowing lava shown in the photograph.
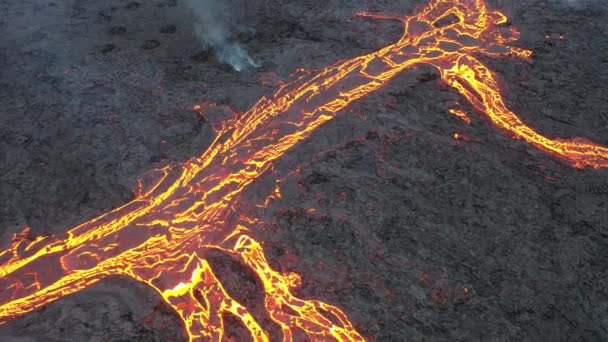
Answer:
[0,0,608,341]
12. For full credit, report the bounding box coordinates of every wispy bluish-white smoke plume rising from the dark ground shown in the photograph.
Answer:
[187,0,259,71]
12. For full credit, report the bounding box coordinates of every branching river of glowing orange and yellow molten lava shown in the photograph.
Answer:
[0,0,608,341]
